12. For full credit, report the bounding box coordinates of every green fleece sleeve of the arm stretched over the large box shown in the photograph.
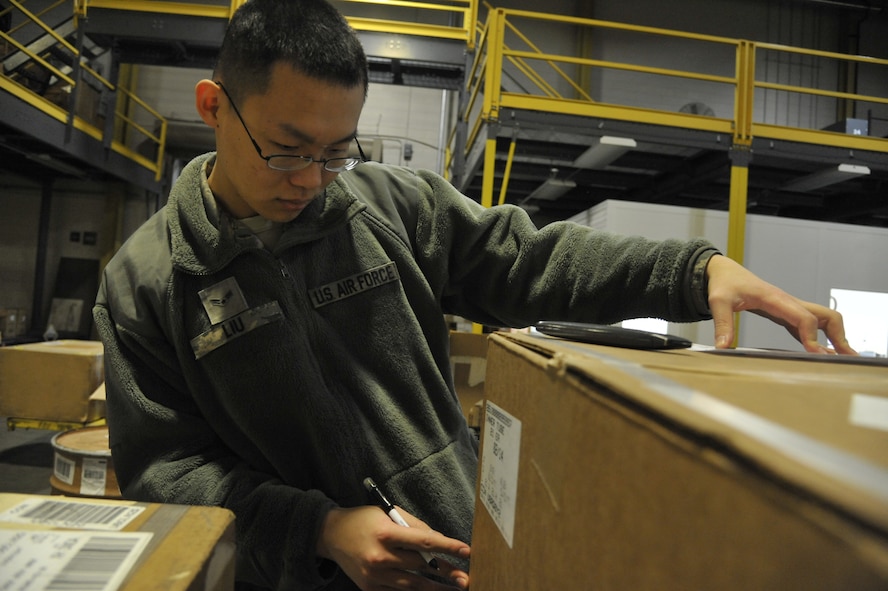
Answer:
[412,172,716,327]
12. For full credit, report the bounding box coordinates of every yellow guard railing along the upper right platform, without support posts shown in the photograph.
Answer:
[458,7,888,183]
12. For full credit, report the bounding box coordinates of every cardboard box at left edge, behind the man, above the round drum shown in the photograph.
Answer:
[0,340,105,422]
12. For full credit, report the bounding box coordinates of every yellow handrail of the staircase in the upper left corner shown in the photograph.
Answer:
[0,0,167,180]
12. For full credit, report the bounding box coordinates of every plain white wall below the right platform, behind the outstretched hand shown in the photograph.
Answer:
[572,201,888,349]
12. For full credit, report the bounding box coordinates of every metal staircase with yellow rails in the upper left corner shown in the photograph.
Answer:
[0,0,166,191]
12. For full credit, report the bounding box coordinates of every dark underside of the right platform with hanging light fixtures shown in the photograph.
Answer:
[458,118,888,227]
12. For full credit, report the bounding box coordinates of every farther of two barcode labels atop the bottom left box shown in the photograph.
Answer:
[0,499,145,531]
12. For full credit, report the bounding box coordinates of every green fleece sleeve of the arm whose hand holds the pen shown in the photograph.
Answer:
[93,269,341,589]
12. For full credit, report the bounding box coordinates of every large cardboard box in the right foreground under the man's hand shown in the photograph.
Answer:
[471,333,888,591]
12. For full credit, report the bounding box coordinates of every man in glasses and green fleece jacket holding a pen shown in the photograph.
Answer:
[95,0,853,590]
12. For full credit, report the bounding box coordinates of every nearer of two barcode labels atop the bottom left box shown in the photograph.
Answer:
[0,530,152,591]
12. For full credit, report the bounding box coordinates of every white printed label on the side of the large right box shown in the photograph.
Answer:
[480,401,521,548]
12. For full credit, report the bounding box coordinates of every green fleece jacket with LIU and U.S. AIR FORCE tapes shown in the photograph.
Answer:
[94,154,711,589]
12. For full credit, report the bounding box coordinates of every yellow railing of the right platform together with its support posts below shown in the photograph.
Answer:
[444,3,888,286]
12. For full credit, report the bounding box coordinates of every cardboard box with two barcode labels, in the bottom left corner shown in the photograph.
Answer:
[0,493,235,591]
